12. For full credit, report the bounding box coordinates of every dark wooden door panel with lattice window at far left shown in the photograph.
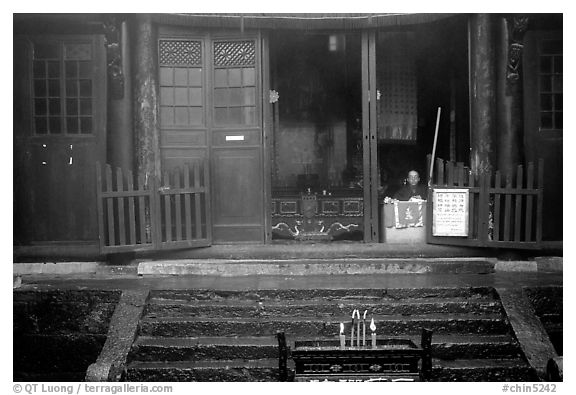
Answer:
[14,36,106,245]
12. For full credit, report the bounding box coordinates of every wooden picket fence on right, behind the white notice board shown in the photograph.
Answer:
[427,156,544,249]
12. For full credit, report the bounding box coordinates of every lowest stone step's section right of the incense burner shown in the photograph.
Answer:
[432,359,539,382]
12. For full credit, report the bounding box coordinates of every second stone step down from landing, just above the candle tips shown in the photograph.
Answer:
[145,297,502,319]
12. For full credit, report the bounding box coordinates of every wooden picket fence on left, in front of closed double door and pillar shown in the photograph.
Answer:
[96,162,212,253]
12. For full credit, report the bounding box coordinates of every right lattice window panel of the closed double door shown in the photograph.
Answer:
[214,41,257,126]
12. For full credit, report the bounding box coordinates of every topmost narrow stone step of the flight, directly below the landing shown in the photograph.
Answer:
[149,287,498,304]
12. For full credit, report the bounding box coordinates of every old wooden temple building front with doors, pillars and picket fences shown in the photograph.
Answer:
[13,14,563,257]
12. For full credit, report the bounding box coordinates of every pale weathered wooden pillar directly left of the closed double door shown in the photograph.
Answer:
[134,14,160,184]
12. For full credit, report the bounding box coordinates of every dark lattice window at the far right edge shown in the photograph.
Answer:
[539,39,563,130]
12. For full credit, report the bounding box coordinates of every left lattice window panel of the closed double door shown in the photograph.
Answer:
[159,39,204,127]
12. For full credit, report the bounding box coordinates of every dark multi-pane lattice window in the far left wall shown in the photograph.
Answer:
[32,40,94,134]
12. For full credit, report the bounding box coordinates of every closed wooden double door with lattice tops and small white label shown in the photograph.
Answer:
[158,28,265,244]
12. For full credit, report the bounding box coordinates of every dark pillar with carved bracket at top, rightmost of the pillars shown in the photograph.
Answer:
[496,16,528,178]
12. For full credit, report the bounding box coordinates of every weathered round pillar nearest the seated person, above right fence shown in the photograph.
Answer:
[468,14,496,175]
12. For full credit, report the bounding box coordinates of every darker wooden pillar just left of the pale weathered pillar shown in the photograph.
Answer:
[108,21,134,171]
